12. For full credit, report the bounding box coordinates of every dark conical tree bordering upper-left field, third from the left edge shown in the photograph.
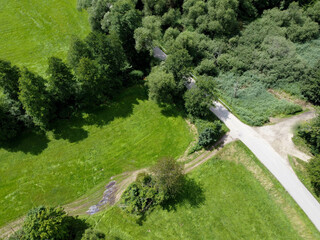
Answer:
[47,57,75,104]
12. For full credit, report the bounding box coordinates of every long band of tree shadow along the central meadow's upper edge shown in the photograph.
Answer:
[0,85,147,155]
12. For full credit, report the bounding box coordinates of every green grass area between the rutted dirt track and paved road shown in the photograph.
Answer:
[88,142,319,240]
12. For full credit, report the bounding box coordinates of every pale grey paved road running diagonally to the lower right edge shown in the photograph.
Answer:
[210,102,320,231]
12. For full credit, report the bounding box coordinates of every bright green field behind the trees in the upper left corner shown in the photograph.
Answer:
[0,0,90,74]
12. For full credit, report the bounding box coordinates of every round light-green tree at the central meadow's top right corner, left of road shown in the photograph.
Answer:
[146,67,176,103]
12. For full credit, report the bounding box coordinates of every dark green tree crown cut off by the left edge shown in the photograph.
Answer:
[0,59,20,100]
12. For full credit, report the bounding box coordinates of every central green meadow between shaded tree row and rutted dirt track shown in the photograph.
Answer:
[0,86,193,226]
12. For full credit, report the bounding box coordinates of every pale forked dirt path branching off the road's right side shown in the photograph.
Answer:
[254,111,315,161]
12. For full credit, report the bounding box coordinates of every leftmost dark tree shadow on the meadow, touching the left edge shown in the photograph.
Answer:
[0,130,49,155]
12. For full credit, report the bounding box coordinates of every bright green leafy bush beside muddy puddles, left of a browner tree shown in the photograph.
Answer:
[122,173,165,215]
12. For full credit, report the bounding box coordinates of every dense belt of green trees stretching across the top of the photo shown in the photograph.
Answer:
[0,0,320,140]
